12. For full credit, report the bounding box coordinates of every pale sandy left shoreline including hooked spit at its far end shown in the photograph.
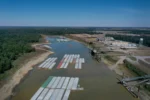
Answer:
[0,35,53,100]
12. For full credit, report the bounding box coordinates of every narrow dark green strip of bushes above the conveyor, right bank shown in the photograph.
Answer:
[124,60,147,76]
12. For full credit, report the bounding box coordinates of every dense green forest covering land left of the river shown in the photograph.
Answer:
[0,29,40,74]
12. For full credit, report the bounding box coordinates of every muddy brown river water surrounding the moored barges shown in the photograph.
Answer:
[11,38,137,100]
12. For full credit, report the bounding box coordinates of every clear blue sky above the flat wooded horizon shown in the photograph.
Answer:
[0,0,150,27]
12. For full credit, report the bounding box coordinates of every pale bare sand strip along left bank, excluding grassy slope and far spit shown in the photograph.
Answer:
[0,52,52,100]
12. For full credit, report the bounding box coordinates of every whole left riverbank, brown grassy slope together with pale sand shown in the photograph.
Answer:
[0,35,53,100]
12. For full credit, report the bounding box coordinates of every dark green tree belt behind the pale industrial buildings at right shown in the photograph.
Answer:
[106,34,150,47]
